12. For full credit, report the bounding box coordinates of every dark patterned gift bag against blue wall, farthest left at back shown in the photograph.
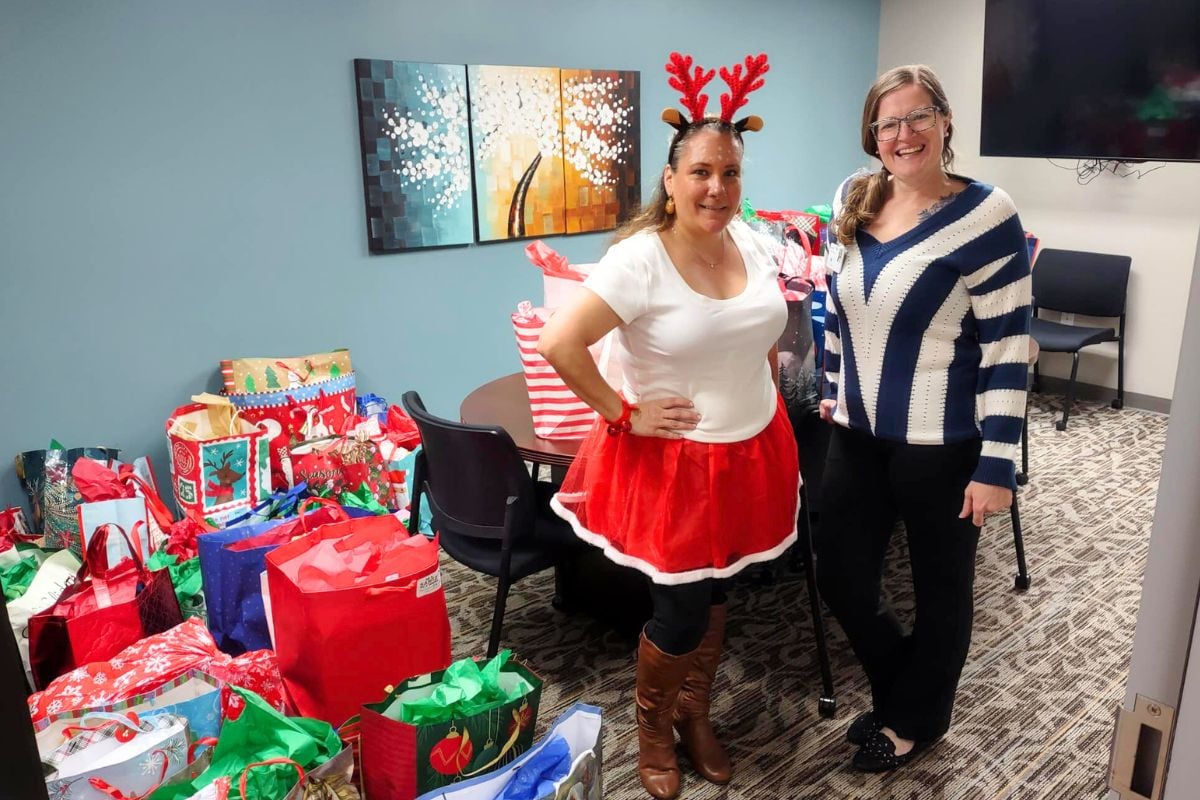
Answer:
[14,447,120,555]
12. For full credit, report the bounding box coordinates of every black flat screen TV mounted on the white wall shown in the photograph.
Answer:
[979,0,1200,161]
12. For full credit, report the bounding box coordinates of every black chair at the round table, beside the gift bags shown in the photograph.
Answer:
[401,391,577,658]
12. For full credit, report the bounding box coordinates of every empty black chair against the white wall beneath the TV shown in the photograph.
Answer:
[1030,248,1132,431]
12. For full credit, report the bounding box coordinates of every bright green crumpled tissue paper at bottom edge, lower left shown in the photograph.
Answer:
[150,686,342,800]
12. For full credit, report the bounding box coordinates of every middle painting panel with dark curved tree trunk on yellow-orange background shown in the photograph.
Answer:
[467,65,566,241]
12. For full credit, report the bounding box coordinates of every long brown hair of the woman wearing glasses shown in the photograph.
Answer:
[836,64,954,245]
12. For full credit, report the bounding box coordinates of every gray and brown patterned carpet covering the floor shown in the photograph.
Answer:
[436,397,1166,800]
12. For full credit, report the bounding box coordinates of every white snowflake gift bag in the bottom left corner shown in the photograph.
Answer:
[42,714,188,800]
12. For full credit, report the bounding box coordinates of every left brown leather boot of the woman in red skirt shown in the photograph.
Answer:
[636,633,695,800]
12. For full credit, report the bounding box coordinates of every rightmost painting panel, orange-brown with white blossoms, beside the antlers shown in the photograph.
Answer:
[562,70,641,234]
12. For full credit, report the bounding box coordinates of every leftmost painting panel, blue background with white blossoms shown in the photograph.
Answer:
[354,59,475,253]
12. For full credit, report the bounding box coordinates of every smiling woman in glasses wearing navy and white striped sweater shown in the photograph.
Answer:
[816,65,1030,771]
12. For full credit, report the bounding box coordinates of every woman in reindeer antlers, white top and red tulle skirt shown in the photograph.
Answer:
[539,53,799,798]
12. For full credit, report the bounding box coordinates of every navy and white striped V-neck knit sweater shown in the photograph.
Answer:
[824,181,1031,488]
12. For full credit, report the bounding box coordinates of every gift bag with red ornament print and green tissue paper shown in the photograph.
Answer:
[361,650,542,800]
